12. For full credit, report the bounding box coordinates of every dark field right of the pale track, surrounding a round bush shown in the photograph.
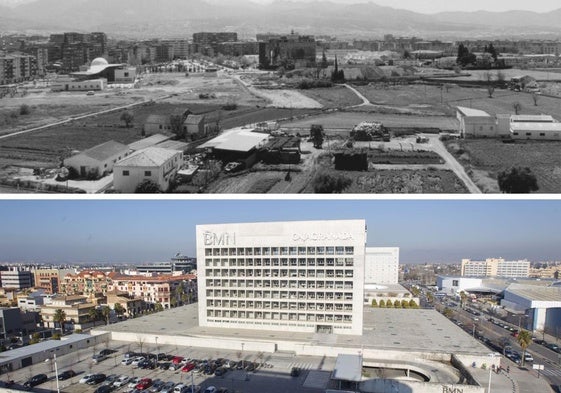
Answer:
[447,140,561,194]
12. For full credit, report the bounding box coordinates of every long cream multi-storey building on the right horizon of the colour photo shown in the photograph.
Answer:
[461,258,530,277]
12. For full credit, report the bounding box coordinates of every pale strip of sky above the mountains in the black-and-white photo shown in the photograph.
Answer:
[253,0,561,13]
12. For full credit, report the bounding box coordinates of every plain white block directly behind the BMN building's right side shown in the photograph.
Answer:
[364,247,399,284]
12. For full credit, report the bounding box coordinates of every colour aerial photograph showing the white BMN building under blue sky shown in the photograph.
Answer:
[0,200,561,393]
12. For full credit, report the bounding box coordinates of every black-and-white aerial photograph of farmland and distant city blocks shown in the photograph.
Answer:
[0,0,561,195]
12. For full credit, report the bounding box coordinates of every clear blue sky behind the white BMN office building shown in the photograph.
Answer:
[0,200,561,263]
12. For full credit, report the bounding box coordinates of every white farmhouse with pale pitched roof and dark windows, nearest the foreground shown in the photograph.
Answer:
[113,147,183,193]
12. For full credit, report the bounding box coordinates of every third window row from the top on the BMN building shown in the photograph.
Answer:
[205,269,354,278]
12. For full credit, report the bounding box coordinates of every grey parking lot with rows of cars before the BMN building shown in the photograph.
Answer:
[3,342,335,393]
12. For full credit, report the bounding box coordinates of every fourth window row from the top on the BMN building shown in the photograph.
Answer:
[206,279,353,289]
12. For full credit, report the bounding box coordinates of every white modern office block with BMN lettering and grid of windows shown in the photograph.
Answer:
[197,220,366,335]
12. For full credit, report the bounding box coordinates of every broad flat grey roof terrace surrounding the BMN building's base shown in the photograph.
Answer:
[99,303,489,355]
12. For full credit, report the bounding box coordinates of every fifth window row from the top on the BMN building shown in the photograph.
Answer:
[206,289,353,302]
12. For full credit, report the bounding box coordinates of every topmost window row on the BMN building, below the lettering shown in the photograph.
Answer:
[205,246,354,256]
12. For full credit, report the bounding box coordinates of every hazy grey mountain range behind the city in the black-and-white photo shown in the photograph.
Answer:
[0,0,561,39]
